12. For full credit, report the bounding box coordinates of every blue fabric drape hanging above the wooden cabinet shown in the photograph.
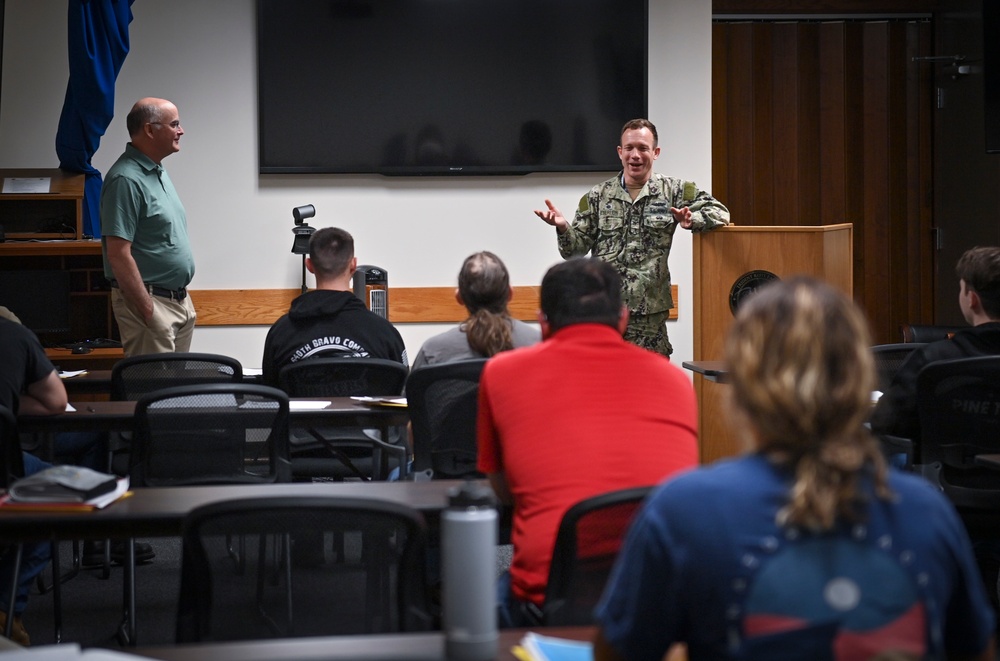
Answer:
[56,0,134,238]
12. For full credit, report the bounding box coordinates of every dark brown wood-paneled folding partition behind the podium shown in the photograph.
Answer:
[712,19,934,343]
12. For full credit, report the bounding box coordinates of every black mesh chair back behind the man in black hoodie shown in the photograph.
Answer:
[278,356,409,397]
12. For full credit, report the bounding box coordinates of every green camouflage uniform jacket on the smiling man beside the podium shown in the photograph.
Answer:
[558,173,729,315]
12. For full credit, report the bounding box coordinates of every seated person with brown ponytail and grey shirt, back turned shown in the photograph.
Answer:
[413,250,542,369]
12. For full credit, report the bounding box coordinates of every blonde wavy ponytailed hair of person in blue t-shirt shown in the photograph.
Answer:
[725,277,891,530]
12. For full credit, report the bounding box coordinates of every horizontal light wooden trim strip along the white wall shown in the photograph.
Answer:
[191,285,677,326]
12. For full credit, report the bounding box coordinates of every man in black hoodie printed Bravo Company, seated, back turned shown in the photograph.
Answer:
[262,227,408,387]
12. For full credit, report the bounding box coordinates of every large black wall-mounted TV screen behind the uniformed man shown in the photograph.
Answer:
[257,0,649,175]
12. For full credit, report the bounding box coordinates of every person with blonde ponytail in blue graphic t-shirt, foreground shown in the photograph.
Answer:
[595,278,995,661]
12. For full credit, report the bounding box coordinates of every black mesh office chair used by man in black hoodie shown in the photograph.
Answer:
[278,356,408,480]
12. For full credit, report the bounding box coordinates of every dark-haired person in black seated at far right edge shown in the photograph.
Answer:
[871,246,1000,442]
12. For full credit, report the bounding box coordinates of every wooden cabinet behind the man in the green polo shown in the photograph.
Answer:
[0,169,121,359]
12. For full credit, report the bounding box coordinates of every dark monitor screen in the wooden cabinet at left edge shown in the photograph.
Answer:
[0,269,70,333]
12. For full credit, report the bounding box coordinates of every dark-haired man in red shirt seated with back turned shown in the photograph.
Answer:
[478,258,698,626]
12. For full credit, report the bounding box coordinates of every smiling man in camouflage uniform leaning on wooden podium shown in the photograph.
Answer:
[535,119,729,357]
